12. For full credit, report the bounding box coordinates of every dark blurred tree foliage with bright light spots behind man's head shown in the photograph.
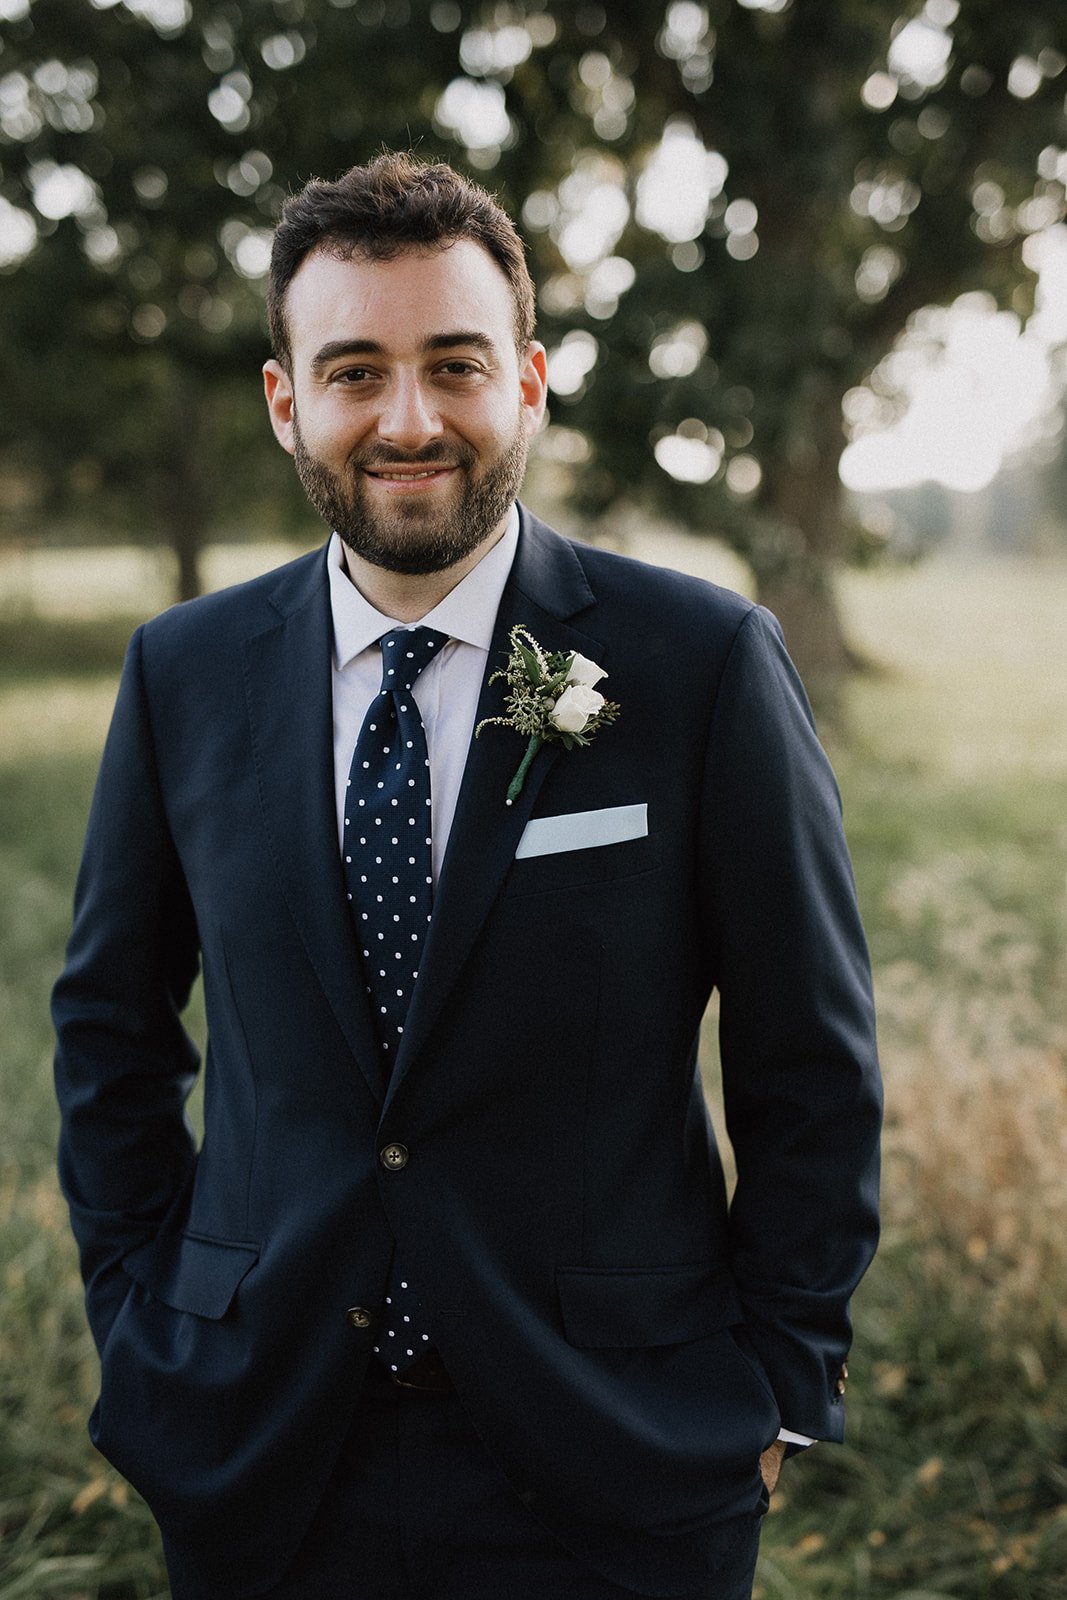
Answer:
[0,0,1067,682]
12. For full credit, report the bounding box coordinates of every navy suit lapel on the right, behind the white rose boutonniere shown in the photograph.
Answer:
[389,510,600,1098]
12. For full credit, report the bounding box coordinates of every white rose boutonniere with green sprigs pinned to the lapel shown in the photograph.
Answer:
[475,624,619,805]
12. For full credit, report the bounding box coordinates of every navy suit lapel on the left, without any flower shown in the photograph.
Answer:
[245,557,384,1101]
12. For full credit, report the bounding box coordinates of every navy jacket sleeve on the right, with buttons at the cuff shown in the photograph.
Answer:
[702,608,881,1438]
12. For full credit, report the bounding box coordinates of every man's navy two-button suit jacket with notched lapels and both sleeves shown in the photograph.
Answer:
[54,512,880,1594]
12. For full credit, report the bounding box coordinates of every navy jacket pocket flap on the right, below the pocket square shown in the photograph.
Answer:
[557,1261,744,1350]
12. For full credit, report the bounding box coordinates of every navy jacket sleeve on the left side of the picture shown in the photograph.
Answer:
[53,630,198,1349]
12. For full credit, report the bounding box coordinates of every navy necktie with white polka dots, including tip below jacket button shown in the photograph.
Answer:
[342,627,448,1373]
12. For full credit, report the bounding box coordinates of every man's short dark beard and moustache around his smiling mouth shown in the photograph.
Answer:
[293,413,528,574]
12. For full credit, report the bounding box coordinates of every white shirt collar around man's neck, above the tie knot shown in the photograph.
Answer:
[326,506,518,670]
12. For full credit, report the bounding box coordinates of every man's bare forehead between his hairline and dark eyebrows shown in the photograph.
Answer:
[285,238,515,365]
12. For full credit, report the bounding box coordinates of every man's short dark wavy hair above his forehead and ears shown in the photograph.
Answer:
[267,150,534,373]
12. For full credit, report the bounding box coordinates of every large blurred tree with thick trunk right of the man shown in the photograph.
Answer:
[486,0,1067,696]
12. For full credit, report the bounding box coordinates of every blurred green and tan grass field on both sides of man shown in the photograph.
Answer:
[0,541,1067,1600]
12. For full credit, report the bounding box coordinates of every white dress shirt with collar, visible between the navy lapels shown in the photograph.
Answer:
[326,506,518,883]
